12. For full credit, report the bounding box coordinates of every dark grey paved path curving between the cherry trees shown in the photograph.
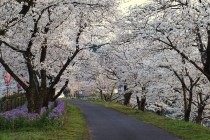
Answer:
[68,100,180,140]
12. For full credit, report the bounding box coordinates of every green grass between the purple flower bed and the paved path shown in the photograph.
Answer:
[0,104,88,140]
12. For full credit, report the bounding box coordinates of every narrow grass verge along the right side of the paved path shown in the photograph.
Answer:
[91,101,210,140]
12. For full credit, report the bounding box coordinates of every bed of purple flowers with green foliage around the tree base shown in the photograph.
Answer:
[0,100,65,129]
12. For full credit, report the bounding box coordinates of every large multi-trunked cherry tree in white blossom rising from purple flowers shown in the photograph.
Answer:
[0,0,118,113]
